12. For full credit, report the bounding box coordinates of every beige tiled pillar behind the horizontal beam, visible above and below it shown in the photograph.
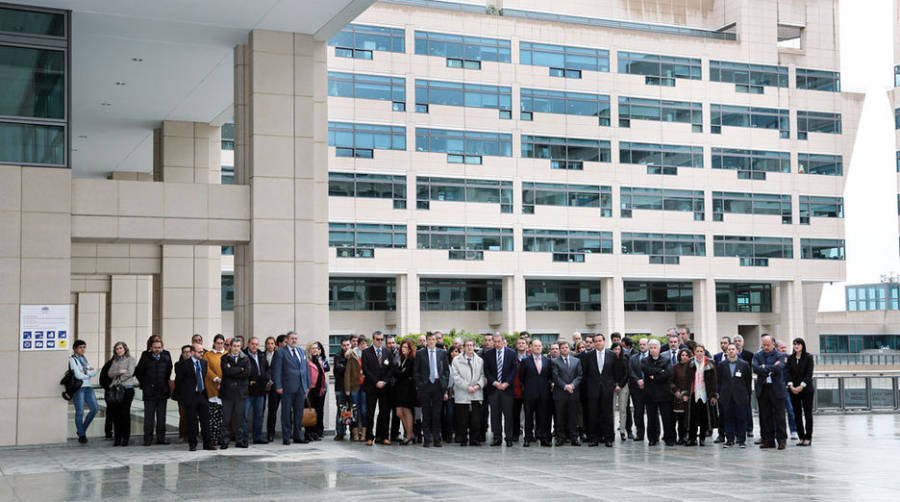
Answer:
[153,120,222,340]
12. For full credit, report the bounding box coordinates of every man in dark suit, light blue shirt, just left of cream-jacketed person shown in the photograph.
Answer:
[414,332,450,448]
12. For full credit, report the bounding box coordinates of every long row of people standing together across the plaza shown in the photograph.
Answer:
[69,328,815,451]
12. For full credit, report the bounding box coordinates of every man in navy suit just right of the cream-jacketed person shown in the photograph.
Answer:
[484,334,517,446]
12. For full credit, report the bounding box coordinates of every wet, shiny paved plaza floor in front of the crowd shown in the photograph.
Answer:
[0,415,900,502]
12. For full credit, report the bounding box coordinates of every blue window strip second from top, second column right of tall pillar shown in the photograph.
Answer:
[416,79,512,113]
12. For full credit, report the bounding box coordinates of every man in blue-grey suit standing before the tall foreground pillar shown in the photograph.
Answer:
[272,331,310,445]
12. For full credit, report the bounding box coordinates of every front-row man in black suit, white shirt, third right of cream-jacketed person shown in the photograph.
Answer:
[584,333,616,448]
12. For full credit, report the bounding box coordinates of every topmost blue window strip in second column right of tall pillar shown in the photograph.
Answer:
[416,31,511,63]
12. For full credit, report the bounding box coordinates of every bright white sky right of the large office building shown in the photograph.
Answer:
[819,0,900,310]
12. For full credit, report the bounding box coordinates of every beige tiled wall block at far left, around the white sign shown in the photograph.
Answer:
[0,166,71,445]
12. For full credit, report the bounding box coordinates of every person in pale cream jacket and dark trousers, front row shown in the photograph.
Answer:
[450,340,485,446]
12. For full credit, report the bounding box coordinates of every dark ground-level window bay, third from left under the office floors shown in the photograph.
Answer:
[525,280,601,312]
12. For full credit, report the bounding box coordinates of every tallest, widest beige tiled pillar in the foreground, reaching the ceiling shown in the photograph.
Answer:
[234,30,328,343]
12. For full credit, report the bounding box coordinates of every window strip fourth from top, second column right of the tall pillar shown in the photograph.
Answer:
[416,176,512,213]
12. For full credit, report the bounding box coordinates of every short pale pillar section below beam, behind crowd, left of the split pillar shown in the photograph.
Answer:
[109,275,153,354]
